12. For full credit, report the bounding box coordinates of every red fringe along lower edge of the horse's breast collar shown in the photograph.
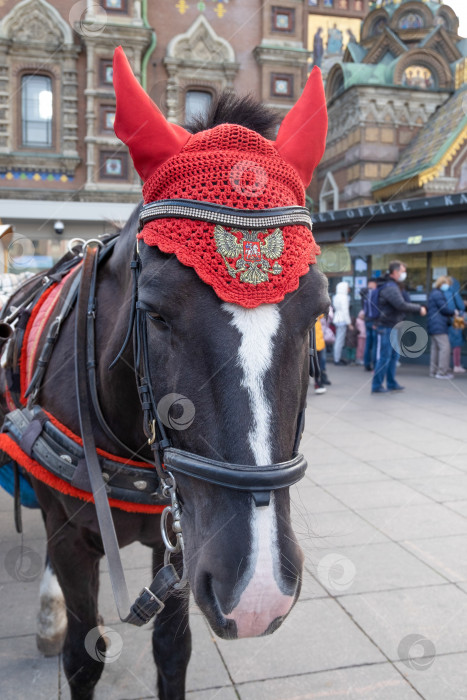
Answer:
[0,433,165,514]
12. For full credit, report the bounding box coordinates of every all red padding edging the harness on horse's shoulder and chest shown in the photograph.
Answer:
[0,268,165,513]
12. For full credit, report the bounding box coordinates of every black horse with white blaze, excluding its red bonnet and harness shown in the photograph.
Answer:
[0,49,329,700]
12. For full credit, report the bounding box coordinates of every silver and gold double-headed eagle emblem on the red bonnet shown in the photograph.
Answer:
[214,224,284,284]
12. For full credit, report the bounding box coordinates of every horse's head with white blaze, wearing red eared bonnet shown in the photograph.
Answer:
[114,49,329,638]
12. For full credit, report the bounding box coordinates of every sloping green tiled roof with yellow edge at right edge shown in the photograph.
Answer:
[372,85,467,190]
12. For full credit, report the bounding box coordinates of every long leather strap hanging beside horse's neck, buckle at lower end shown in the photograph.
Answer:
[75,246,179,626]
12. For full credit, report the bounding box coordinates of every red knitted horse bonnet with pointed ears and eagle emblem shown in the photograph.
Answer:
[114,47,327,308]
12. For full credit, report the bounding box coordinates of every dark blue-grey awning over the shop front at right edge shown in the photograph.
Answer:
[347,214,467,257]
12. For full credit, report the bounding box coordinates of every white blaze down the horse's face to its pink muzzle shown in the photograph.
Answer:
[223,304,294,637]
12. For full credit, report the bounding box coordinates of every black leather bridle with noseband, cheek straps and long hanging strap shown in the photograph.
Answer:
[75,203,307,625]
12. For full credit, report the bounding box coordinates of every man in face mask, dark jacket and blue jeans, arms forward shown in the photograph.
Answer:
[371,260,426,394]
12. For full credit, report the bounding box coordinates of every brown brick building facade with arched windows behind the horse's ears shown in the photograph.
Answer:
[0,0,310,268]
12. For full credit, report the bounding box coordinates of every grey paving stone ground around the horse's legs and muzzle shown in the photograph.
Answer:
[0,365,467,700]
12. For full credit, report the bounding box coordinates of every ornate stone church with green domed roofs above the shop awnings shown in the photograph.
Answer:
[313,0,467,211]
